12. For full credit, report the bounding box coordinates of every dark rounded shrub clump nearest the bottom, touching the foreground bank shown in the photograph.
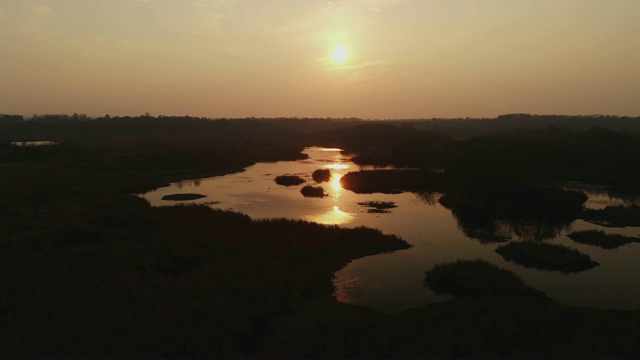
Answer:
[424,259,544,298]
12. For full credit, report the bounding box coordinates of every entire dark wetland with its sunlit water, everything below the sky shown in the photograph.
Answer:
[0,116,640,358]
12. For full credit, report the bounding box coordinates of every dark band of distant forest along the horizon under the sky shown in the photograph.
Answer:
[0,113,640,141]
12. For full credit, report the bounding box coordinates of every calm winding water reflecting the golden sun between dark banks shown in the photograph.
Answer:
[141,148,640,312]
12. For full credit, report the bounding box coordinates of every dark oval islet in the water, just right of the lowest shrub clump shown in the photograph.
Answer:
[496,241,600,273]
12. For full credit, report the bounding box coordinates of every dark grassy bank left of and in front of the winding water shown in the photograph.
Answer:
[0,121,640,357]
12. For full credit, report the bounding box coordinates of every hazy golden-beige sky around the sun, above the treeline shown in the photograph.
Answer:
[0,0,640,119]
